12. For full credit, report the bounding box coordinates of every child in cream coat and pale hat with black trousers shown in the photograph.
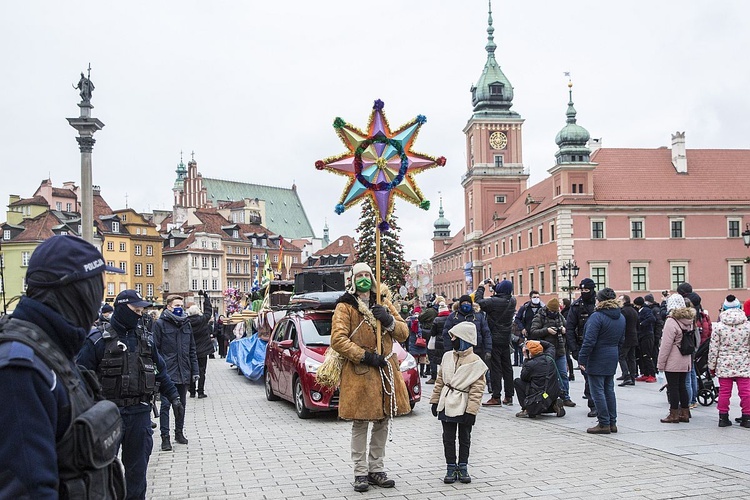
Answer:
[430,321,487,484]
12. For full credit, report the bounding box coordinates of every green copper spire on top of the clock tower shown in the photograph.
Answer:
[471,0,520,118]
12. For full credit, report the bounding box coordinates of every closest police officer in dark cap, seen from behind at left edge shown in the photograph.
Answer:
[0,236,125,499]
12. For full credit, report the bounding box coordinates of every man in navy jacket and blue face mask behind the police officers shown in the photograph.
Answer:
[152,295,200,451]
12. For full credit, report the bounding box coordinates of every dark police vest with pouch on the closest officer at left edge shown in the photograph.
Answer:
[0,316,125,499]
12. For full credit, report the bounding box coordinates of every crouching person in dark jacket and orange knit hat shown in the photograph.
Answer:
[514,340,565,418]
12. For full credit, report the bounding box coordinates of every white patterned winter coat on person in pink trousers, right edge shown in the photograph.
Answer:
[708,309,750,378]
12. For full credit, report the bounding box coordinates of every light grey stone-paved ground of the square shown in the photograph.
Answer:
[148,359,750,500]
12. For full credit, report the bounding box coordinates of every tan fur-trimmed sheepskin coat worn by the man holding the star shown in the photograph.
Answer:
[331,286,411,421]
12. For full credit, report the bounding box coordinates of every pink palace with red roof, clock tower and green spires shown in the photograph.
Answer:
[432,9,750,317]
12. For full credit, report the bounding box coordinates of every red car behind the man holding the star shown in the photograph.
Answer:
[263,292,422,418]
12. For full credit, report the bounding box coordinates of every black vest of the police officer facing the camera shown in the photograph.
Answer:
[96,325,156,408]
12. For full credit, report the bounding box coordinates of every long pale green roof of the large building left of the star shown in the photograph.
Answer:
[203,177,315,240]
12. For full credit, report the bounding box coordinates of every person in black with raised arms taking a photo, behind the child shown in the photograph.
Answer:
[474,279,516,406]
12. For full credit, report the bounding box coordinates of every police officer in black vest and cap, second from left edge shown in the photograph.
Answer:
[78,290,184,499]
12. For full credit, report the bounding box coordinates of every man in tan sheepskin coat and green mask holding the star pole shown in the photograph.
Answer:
[331,262,411,492]
